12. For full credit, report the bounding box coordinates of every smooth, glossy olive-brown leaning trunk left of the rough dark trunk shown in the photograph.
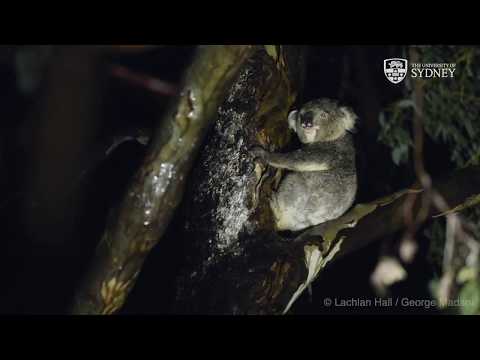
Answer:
[72,45,254,314]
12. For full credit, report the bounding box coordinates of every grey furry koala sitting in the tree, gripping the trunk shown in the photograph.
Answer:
[252,99,357,231]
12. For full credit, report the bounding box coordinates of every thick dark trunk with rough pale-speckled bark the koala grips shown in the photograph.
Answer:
[174,46,305,314]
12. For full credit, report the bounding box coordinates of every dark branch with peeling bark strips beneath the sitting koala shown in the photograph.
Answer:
[248,167,480,314]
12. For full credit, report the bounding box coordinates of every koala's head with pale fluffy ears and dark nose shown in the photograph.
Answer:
[288,99,357,144]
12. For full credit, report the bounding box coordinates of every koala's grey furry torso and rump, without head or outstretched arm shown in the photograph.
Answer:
[271,134,357,231]
